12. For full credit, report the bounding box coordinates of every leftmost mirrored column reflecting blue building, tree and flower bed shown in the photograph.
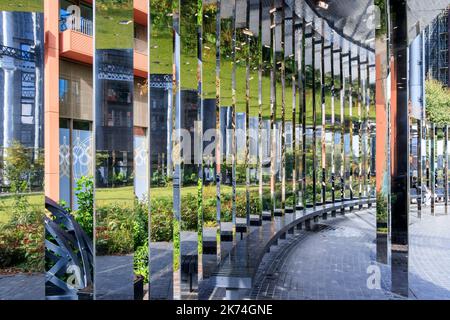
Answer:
[0,0,44,300]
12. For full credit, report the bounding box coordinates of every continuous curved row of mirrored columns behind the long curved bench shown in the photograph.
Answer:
[102,0,380,299]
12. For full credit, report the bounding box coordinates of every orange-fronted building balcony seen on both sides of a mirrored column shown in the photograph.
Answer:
[59,17,148,78]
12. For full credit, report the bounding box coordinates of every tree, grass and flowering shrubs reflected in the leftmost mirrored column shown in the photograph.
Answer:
[0,141,44,272]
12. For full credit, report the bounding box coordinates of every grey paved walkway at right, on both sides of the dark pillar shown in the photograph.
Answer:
[246,208,450,300]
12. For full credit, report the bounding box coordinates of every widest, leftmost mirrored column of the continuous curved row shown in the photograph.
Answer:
[148,0,174,300]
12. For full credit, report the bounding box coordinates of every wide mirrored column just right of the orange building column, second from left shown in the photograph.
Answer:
[93,0,133,300]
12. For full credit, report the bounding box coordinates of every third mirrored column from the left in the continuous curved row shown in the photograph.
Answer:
[199,1,221,299]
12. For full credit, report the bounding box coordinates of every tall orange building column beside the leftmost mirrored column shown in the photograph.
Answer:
[44,1,59,201]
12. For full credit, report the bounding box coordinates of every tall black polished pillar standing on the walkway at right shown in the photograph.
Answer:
[389,0,412,296]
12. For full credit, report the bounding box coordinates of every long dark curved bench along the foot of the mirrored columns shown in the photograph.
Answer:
[211,198,375,299]
